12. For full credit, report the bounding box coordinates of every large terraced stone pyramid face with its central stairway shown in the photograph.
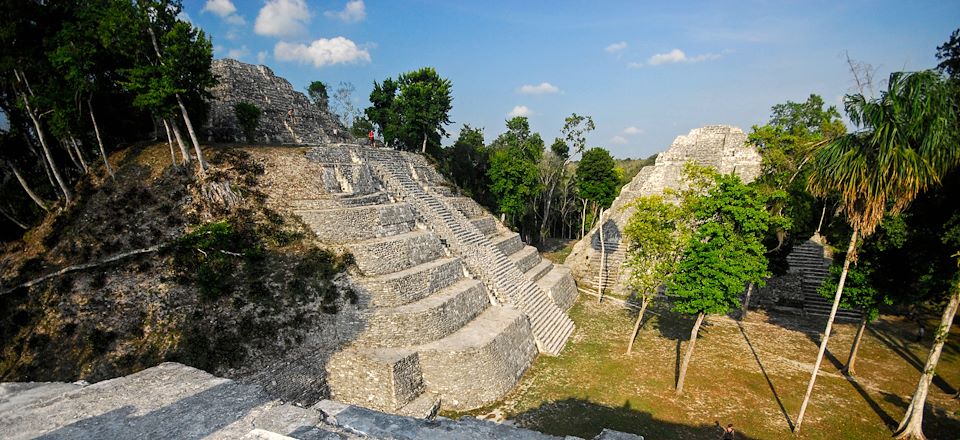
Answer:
[289,145,577,416]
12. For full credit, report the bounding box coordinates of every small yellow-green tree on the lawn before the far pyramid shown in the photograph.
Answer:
[623,196,692,354]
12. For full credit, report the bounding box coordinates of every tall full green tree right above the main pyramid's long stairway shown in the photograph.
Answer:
[487,116,544,234]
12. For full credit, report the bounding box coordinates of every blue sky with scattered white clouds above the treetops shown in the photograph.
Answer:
[184,0,960,158]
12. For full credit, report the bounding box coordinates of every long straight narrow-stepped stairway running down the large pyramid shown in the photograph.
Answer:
[364,148,574,355]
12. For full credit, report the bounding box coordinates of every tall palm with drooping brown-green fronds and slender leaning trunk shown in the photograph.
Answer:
[794,71,960,438]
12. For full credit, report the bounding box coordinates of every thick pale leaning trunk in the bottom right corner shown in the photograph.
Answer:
[893,284,960,439]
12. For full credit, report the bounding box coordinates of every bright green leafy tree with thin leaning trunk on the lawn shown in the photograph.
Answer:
[667,174,771,395]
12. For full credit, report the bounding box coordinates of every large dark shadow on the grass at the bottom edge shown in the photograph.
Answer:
[513,398,754,440]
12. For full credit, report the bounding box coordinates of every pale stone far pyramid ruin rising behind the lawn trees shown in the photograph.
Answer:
[564,125,761,294]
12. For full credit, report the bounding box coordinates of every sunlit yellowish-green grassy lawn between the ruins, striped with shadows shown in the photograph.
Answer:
[456,295,960,439]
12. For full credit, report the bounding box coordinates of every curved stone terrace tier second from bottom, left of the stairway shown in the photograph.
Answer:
[359,278,490,347]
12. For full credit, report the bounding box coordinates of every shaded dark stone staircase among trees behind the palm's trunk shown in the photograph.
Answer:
[787,239,862,321]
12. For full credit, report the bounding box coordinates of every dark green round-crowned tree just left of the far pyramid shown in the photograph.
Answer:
[576,147,620,236]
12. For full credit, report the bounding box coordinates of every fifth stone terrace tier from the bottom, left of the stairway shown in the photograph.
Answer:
[294,203,416,243]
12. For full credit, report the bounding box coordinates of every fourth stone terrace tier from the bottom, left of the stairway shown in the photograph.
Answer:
[348,230,444,275]
